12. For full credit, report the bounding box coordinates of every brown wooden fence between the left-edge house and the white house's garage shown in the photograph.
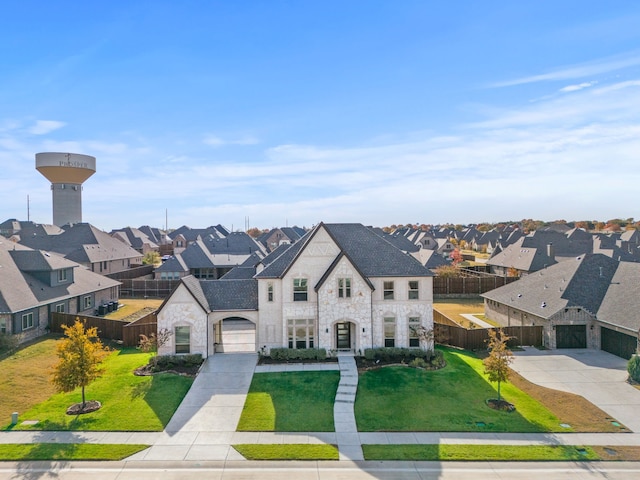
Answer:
[49,312,158,347]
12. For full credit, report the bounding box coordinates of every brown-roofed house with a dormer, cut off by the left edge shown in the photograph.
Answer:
[0,239,120,341]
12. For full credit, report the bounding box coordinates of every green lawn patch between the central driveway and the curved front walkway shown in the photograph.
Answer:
[238,371,340,432]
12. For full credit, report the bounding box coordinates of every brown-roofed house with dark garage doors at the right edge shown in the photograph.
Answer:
[482,254,640,358]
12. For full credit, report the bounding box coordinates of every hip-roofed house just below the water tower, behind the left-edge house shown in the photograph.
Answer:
[20,223,142,275]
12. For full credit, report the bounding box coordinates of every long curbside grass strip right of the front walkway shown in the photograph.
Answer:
[362,444,600,462]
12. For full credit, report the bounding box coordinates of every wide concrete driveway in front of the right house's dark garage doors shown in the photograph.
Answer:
[512,347,640,432]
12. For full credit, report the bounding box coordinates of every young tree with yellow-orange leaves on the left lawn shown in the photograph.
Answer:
[51,318,109,411]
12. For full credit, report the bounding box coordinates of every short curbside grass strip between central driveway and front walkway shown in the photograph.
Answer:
[232,443,340,460]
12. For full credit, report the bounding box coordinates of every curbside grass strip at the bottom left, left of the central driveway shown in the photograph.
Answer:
[0,443,149,462]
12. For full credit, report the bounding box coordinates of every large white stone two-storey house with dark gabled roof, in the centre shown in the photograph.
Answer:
[158,223,433,357]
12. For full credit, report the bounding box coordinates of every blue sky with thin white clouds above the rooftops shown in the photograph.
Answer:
[0,0,640,230]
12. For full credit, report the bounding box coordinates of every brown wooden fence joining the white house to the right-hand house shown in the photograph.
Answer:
[434,322,542,350]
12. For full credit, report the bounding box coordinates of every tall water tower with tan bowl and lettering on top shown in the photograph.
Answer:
[36,152,96,227]
